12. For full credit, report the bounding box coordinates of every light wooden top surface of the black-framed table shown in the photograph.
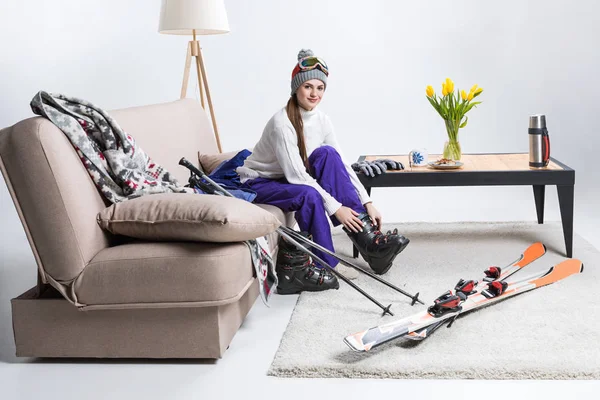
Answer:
[361,153,565,173]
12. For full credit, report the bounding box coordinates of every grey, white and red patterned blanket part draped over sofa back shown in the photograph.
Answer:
[31,91,194,203]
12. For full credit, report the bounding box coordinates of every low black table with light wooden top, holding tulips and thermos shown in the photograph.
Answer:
[354,153,575,257]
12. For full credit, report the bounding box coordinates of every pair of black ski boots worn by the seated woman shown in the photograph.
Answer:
[276,213,409,294]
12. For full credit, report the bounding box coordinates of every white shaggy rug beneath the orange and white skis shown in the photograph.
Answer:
[268,222,600,379]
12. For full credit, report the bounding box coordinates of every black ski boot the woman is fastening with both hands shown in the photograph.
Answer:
[344,213,410,275]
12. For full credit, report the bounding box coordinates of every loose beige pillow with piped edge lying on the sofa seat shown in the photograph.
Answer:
[97,193,281,242]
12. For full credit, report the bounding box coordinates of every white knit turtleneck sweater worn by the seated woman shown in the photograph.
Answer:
[237,107,371,215]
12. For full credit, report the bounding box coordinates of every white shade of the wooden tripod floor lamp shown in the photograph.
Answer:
[158,0,229,35]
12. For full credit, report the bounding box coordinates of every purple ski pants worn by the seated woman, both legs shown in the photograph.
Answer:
[243,146,366,267]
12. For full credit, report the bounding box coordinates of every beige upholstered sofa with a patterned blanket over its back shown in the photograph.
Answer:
[0,99,289,358]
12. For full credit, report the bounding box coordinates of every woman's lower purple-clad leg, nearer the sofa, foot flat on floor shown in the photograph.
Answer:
[244,178,338,267]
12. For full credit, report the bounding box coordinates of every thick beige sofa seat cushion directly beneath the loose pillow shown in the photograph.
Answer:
[73,242,253,307]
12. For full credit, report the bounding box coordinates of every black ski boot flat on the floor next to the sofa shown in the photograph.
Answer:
[275,232,340,294]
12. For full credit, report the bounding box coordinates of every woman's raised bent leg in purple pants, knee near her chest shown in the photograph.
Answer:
[308,146,367,226]
